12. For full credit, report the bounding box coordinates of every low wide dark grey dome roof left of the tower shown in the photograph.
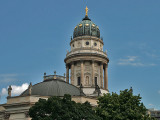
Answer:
[20,79,85,96]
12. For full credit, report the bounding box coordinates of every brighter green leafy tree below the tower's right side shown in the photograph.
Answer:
[96,88,154,120]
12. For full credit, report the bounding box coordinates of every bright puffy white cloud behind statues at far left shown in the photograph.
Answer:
[1,83,29,96]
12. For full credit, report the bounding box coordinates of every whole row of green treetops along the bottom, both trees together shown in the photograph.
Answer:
[29,89,155,120]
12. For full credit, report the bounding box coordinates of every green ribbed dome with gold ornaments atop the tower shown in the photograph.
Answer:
[73,15,100,38]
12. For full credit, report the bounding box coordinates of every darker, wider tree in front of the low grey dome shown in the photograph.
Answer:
[29,95,101,120]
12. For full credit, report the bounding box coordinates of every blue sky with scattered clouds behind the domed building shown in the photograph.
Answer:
[0,0,160,109]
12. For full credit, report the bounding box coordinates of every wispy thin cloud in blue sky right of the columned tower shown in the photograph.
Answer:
[117,56,156,67]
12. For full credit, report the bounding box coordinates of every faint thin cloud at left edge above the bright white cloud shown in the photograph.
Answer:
[0,74,18,83]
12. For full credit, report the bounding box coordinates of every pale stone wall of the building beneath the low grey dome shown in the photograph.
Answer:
[0,95,97,120]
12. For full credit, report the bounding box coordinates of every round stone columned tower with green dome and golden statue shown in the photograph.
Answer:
[64,7,109,96]
